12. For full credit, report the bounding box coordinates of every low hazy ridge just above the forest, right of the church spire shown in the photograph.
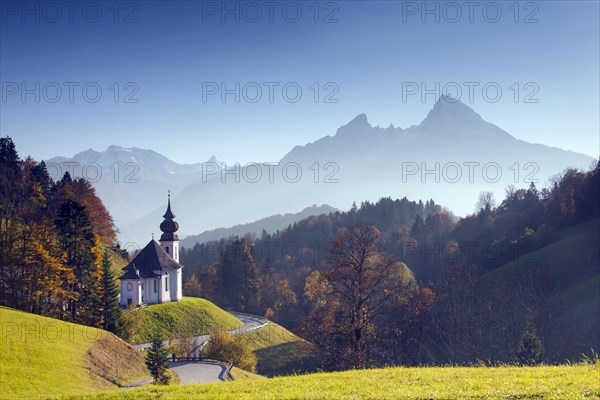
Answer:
[181,204,339,248]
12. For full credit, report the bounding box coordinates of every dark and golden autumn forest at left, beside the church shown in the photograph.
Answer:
[0,137,121,332]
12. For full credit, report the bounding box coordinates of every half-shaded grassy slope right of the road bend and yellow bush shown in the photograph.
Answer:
[243,322,319,376]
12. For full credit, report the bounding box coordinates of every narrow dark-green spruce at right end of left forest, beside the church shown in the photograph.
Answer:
[101,251,123,336]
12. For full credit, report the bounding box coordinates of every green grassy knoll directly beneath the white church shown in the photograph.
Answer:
[133,297,242,343]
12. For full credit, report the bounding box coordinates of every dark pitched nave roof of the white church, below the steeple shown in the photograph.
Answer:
[119,240,182,279]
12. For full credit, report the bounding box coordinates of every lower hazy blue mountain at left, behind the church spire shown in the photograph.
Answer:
[46,146,220,228]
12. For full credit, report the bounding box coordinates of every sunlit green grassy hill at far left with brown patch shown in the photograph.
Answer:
[0,307,150,398]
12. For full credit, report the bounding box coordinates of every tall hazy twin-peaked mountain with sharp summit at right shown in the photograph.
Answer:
[123,97,593,245]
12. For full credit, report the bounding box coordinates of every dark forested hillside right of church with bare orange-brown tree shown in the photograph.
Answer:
[182,164,600,368]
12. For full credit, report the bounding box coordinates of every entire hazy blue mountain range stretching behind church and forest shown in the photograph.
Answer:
[48,96,594,245]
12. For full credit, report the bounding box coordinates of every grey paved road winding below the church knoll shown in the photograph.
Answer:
[125,311,269,387]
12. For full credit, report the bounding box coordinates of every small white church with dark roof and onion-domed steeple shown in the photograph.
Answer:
[119,194,183,307]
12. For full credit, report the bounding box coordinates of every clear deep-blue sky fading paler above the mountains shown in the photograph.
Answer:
[0,0,600,163]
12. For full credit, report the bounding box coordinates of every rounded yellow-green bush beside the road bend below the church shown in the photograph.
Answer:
[202,331,256,372]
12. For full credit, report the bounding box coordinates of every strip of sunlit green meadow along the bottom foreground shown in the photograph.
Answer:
[58,363,600,400]
